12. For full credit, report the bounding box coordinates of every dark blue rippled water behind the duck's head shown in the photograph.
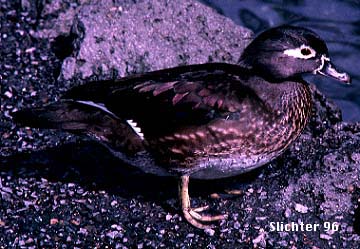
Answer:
[202,0,360,121]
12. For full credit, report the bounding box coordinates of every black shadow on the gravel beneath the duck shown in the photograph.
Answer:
[0,141,262,208]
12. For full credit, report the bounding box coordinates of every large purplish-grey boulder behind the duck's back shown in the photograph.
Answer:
[57,1,252,79]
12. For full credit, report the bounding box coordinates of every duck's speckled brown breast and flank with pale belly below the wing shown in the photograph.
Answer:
[148,84,311,179]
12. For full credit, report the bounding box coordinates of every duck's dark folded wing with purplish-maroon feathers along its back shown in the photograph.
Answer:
[64,63,262,136]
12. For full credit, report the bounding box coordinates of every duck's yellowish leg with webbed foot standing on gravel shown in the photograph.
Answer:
[179,175,227,229]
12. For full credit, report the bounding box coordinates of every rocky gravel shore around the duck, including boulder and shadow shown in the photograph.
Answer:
[0,0,360,248]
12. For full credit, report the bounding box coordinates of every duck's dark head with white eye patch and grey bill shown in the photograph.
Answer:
[239,25,351,83]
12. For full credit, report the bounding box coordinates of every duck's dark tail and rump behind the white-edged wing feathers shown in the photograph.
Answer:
[12,100,144,153]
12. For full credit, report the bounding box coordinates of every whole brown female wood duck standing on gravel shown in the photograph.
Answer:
[13,26,350,228]
